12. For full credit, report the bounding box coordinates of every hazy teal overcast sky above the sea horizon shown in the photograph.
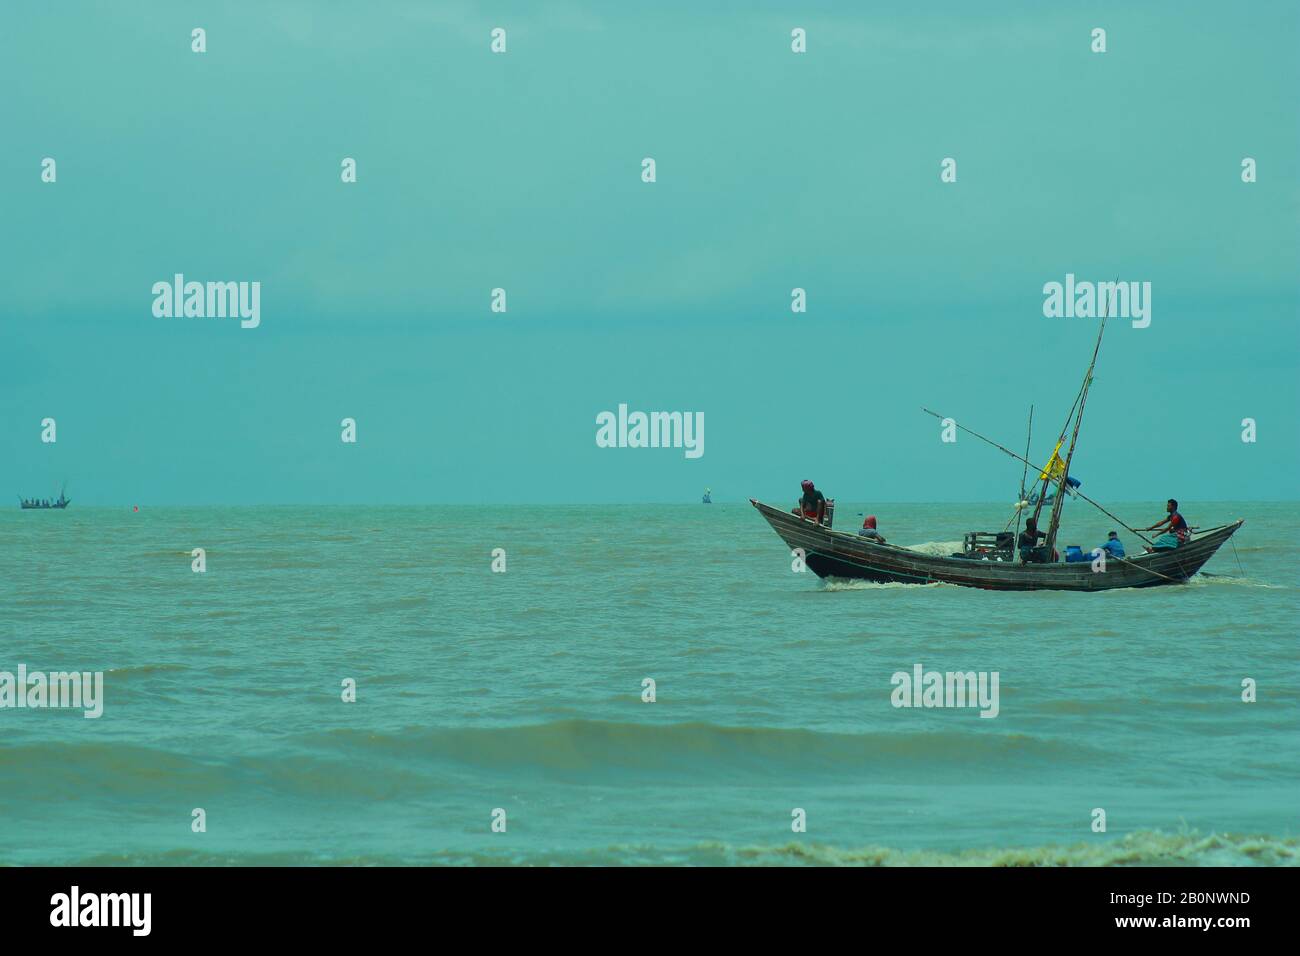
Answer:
[0,0,1300,506]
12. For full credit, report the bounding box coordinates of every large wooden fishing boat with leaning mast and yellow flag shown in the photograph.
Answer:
[749,295,1243,591]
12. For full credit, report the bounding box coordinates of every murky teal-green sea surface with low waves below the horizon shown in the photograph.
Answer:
[0,496,1300,865]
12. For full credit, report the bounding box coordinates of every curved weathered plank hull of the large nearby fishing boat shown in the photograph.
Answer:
[750,498,1242,591]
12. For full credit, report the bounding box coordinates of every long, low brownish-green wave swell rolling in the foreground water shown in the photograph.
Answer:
[0,713,1113,800]
